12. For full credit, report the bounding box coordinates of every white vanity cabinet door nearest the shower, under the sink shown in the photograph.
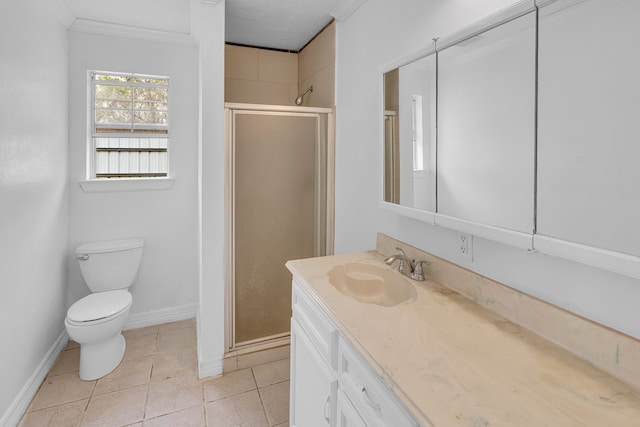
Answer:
[289,318,338,427]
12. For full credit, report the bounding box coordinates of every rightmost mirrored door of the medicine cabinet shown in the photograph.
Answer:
[538,0,640,256]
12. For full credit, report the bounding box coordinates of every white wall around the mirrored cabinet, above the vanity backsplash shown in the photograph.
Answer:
[336,0,640,338]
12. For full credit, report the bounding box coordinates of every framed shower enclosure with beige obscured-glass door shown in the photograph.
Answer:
[225,104,334,351]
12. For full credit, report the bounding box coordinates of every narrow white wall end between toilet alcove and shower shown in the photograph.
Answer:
[198,2,227,377]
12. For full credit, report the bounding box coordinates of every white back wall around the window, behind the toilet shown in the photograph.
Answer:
[67,31,198,315]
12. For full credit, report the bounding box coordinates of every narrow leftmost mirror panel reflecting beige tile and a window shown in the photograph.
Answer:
[384,54,436,212]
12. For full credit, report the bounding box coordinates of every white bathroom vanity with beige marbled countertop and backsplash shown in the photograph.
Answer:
[287,237,640,427]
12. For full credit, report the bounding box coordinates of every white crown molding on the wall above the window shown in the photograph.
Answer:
[69,18,197,44]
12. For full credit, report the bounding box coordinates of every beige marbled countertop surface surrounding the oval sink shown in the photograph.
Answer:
[287,251,640,427]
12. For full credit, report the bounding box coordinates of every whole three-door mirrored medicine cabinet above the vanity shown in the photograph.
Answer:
[381,0,640,278]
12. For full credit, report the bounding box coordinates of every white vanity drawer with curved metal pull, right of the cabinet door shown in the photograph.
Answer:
[338,337,419,427]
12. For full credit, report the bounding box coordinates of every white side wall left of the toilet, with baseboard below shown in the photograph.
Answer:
[0,0,69,424]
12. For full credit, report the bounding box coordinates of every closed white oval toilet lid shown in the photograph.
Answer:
[67,289,132,322]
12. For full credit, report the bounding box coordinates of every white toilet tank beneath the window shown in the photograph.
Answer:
[76,239,144,292]
